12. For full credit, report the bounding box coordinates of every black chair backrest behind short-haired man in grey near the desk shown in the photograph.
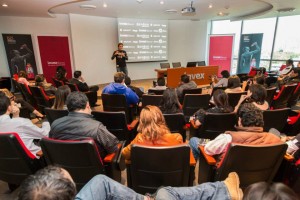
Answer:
[182,94,210,117]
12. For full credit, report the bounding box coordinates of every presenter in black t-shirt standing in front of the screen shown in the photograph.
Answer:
[111,43,128,76]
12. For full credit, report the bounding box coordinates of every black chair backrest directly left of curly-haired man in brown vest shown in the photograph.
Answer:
[198,112,238,140]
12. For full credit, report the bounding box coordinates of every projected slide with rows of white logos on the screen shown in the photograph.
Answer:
[118,19,168,62]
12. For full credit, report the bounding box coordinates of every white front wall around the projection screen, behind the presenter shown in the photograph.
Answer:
[70,14,207,84]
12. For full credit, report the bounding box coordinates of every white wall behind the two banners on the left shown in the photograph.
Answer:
[0,15,71,77]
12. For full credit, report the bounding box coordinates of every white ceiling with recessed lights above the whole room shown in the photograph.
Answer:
[0,0,300,20]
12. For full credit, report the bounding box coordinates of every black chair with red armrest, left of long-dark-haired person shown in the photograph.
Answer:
[29,86,55,113]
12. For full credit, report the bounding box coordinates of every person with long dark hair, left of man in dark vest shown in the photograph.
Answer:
[52,85,71,110]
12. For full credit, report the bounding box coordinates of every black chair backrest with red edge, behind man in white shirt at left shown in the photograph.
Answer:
[0,133,40,185]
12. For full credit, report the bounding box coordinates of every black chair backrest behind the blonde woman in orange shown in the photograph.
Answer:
[130,144,190,194]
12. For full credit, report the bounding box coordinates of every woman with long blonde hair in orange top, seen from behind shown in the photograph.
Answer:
[122,105,183,160]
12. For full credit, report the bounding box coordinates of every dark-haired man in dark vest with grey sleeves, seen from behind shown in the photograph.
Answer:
[49,92,119,158]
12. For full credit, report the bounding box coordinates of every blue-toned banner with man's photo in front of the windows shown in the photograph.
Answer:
[237,33,263,74]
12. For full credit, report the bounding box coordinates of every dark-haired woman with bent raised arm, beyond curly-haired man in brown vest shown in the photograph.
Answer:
[234,84,270,112]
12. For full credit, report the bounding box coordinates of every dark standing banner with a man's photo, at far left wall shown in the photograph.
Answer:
[2,34,37,79]
